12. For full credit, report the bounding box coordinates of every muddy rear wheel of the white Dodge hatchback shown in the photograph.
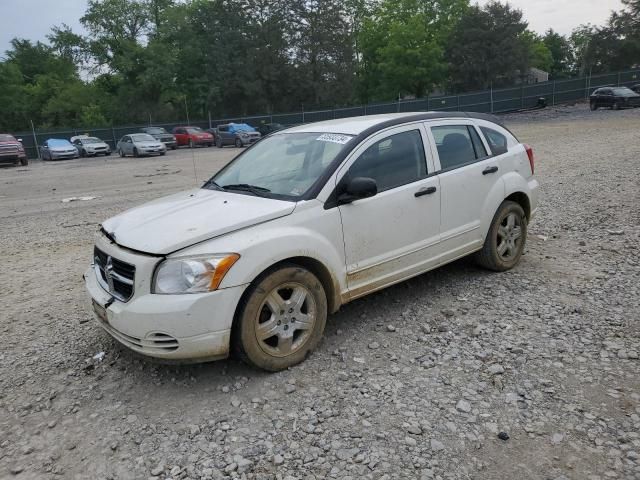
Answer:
[476,200,527,272]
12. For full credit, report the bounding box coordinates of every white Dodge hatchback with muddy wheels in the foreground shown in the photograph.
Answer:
[85,113,538,371]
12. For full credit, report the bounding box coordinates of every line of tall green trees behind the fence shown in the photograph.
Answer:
[0,0,640,131]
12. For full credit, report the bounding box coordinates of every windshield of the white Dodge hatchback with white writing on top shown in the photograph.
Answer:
[205,133,353,200]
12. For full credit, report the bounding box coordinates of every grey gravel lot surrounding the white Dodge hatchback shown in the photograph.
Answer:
[0,106,640,480]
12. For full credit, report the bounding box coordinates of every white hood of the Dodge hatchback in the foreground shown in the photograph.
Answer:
[102,188,296,255]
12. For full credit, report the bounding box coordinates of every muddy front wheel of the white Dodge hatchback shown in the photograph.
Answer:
[232,265,327,372]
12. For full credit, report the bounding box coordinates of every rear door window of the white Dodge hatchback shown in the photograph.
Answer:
[431,125,480,170]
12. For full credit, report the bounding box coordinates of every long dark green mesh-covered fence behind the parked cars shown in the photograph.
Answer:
[16,69,640,158]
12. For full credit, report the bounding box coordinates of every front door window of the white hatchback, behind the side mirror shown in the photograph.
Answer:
[346,130,427,192]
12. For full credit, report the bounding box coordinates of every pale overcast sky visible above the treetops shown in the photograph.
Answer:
[0,0,621,55]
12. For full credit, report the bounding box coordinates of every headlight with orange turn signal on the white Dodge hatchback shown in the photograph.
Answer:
[153,253,240,294]
